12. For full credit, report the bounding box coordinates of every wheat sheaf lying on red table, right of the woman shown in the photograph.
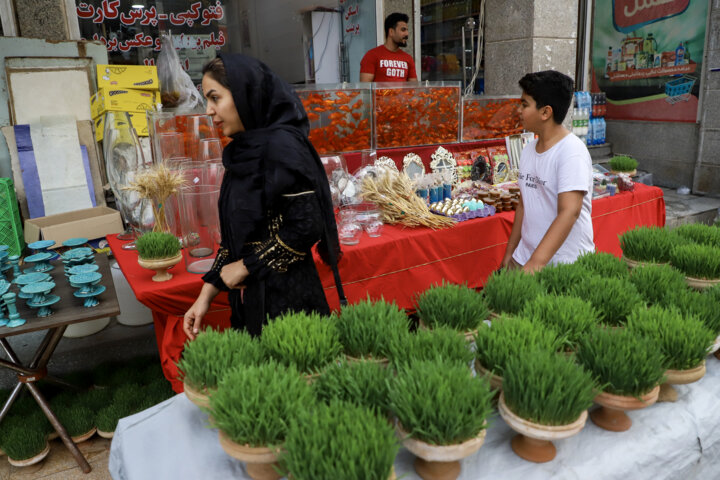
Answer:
[362,173,455,229]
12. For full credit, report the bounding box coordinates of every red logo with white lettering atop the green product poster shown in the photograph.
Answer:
[613,0,690,33]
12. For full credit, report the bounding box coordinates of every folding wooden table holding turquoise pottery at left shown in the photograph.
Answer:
[0,255,120,473]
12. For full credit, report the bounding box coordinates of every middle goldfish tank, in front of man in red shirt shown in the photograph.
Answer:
[373,82,460,148]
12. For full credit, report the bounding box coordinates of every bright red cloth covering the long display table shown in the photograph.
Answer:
[108,184,665,392]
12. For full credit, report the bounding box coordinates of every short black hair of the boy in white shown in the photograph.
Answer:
[518,70,573,124]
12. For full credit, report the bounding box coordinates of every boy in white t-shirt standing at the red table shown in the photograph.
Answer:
[502,70,595,272]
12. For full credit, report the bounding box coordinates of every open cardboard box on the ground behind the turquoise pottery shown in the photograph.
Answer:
[25,207,123,248]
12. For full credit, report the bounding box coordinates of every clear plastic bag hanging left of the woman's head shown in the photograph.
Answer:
[157,33,204,112]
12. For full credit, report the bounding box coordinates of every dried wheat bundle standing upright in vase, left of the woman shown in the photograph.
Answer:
[123,164,185,232]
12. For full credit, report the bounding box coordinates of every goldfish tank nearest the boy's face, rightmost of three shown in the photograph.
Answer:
[462,95,523,142]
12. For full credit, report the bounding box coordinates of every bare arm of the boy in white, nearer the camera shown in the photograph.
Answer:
[524,190,585,272]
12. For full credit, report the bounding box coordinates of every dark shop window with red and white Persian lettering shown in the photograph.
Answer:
[76,0,229,84]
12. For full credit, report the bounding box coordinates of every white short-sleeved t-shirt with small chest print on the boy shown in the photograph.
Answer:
[513,133,595,265]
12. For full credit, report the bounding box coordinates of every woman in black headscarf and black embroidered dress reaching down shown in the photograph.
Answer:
[183,54,345,339]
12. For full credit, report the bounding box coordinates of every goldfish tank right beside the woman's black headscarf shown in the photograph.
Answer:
[295,83,373,155]
